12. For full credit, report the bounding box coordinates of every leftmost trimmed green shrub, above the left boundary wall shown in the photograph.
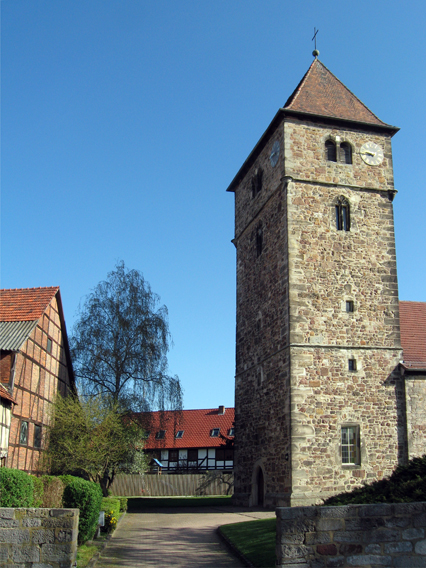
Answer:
[0,467,34,507]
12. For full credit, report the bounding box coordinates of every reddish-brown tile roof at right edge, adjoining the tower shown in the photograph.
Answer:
[399,302,426,369]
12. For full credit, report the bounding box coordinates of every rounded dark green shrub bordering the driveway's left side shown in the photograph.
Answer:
[62,478,102,544]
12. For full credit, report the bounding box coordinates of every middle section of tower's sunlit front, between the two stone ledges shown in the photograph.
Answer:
[288,182,400,348]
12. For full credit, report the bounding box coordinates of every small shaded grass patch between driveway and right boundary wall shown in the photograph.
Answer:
[219,519,277,568]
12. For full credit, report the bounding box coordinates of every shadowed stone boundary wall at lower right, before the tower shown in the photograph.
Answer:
[276,503,426,568]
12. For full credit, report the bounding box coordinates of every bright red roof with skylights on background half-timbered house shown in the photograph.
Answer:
[139,408,235,450]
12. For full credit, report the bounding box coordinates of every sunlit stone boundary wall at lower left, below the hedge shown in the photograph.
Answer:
[0,508,79,568]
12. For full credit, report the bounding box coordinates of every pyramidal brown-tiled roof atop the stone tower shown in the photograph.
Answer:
[284,58,389,126]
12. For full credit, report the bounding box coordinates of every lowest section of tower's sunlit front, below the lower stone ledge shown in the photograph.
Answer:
[291,347,406,505]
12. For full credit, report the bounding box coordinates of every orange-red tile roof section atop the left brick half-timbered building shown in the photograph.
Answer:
[0,286,59,321]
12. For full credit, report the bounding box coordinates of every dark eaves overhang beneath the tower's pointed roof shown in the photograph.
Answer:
[226,108,400,192]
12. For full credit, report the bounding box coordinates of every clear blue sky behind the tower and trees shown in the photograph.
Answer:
[1,0,426,408]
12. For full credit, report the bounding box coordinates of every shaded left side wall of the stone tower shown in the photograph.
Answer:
[234,123,291,505]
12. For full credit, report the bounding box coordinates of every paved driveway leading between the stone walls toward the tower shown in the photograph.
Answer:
[96,507,275,568]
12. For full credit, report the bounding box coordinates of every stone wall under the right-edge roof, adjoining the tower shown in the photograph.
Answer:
[404,374,426,459]
